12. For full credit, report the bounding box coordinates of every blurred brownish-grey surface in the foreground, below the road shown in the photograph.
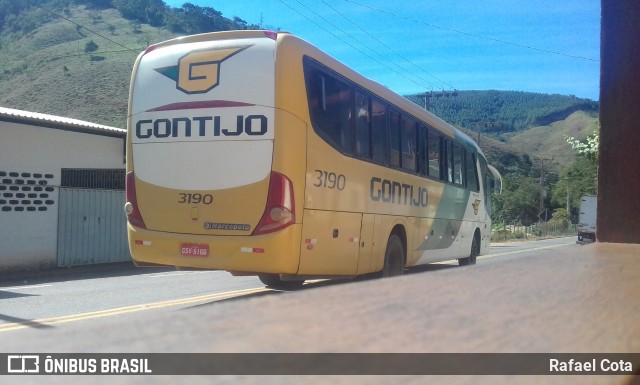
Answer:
[0,240,640,384]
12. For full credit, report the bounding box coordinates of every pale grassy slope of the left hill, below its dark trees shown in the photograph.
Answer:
[0,6,175,128]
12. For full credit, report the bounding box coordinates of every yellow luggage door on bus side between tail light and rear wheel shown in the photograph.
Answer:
[298,210,362,275]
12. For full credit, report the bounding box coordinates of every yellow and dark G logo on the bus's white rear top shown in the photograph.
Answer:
[156,46,250,94]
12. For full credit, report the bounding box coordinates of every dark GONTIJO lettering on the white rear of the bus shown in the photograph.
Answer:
[136,115,268,139]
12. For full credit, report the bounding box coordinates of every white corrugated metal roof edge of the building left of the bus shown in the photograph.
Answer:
[0,107,127,138]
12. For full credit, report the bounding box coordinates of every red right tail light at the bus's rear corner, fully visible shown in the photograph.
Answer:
[252,172,296,235]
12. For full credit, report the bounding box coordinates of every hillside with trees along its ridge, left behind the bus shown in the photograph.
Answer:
[0,0,257,128]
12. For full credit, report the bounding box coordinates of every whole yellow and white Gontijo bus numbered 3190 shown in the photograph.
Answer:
[125,31,500,287]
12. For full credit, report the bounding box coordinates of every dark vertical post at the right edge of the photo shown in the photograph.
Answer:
[597,0,640,243]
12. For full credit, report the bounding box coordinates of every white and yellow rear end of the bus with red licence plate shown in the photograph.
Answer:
[125,31,300,274]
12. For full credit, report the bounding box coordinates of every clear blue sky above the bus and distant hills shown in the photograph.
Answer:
[165,0,600,100]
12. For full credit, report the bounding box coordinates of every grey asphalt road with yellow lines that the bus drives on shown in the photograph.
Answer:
[0,237,575,332]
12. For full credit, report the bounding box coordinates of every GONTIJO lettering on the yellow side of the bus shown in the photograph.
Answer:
[370,176,429,207]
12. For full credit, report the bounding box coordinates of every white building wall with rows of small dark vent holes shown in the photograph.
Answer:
[0,122,124,271]
